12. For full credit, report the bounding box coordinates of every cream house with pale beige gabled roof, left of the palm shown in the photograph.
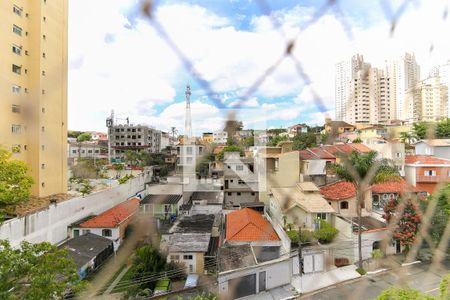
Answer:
[269,182,335,229]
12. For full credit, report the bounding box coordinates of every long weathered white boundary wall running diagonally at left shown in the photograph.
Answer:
[0,172,151,247]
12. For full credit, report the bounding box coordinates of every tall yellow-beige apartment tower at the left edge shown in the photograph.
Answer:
[0,0,67,197]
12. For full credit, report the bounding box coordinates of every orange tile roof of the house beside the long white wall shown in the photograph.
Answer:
[80,198,141,228]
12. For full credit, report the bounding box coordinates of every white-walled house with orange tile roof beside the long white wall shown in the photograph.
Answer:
[69,198,141,251]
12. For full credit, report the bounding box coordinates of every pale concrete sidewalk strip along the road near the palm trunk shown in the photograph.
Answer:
[291,265,361,294]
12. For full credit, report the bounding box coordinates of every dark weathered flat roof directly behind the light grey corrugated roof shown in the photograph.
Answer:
[169,214,215,233]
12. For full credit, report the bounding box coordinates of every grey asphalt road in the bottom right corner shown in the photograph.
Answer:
[300,260,450,300]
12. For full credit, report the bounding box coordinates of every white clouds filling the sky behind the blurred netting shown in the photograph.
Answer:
[69,0,450,131]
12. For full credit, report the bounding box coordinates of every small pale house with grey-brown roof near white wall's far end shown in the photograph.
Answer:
[141,194,183,220]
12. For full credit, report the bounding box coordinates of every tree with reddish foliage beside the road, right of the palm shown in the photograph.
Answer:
[383,199,421,252]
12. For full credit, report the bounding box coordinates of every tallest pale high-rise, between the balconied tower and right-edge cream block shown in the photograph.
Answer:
[386,53,420,120]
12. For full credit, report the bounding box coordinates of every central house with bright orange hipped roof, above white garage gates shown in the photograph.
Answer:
[225,208,281,252]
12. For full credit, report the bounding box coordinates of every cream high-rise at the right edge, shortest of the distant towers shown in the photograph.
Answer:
[404,76,449,122]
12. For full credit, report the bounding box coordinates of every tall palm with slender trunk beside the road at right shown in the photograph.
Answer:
[328,150,401,268]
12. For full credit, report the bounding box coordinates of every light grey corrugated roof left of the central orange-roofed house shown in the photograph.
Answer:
[167,232,211,252]
